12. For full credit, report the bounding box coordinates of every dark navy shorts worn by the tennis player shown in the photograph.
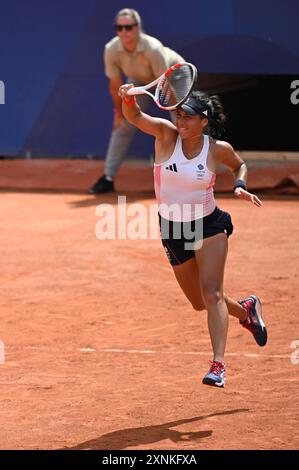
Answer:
[159,207,234,266]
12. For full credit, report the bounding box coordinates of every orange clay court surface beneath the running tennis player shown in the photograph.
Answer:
[0,160,299,450]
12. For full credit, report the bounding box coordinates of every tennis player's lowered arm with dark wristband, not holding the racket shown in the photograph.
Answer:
[214,140,262,207]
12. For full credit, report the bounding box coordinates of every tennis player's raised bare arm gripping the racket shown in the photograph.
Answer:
[118,84,177,141]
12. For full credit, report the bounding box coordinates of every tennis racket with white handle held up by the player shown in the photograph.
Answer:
[128,62,197,111]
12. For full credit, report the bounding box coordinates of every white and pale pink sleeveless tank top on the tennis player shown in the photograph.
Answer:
[154,135,216,222]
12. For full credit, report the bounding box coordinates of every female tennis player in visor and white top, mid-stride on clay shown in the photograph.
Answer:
[119,84,267,387]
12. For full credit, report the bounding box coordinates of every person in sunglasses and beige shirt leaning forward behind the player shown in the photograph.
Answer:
[89,8,184,194]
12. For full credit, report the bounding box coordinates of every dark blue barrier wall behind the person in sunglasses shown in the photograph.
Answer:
[0,0,299,156]
